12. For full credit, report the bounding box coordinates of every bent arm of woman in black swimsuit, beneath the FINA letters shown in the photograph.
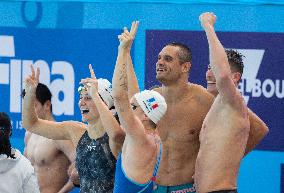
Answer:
[22,66,84,140]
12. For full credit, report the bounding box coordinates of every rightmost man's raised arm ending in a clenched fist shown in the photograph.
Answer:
[199,12,239,104]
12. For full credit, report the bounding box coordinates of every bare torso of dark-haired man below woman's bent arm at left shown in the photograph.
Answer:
[25,132,73,193]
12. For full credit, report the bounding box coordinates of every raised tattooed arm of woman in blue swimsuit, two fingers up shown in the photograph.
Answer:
[112,22,144,139]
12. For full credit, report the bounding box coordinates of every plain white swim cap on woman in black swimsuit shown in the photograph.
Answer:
[98,78,114,109]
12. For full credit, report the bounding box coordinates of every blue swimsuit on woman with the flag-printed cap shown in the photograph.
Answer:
[113,142,162,193]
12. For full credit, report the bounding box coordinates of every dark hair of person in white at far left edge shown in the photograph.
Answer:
[0,112,15,159]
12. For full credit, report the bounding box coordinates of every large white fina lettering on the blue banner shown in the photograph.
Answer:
[0,35,74,116]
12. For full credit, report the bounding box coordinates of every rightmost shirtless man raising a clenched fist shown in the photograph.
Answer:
[194,13,250,193]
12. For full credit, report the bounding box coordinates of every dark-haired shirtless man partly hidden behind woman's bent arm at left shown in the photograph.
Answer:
[24,83,75,193]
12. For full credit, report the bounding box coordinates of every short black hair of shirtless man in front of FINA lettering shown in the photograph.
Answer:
[22,83,52,112]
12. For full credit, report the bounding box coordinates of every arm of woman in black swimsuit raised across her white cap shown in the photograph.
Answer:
[81,64,125,157]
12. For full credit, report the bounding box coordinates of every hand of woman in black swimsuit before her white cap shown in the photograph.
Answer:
[80,64,98,96]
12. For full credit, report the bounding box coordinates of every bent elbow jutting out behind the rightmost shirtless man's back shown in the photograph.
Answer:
[245,109,269,155]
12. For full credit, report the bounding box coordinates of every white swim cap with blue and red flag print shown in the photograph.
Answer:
[134,90,167,124]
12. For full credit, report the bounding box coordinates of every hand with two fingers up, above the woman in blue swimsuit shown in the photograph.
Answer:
[118,21,139,49]
